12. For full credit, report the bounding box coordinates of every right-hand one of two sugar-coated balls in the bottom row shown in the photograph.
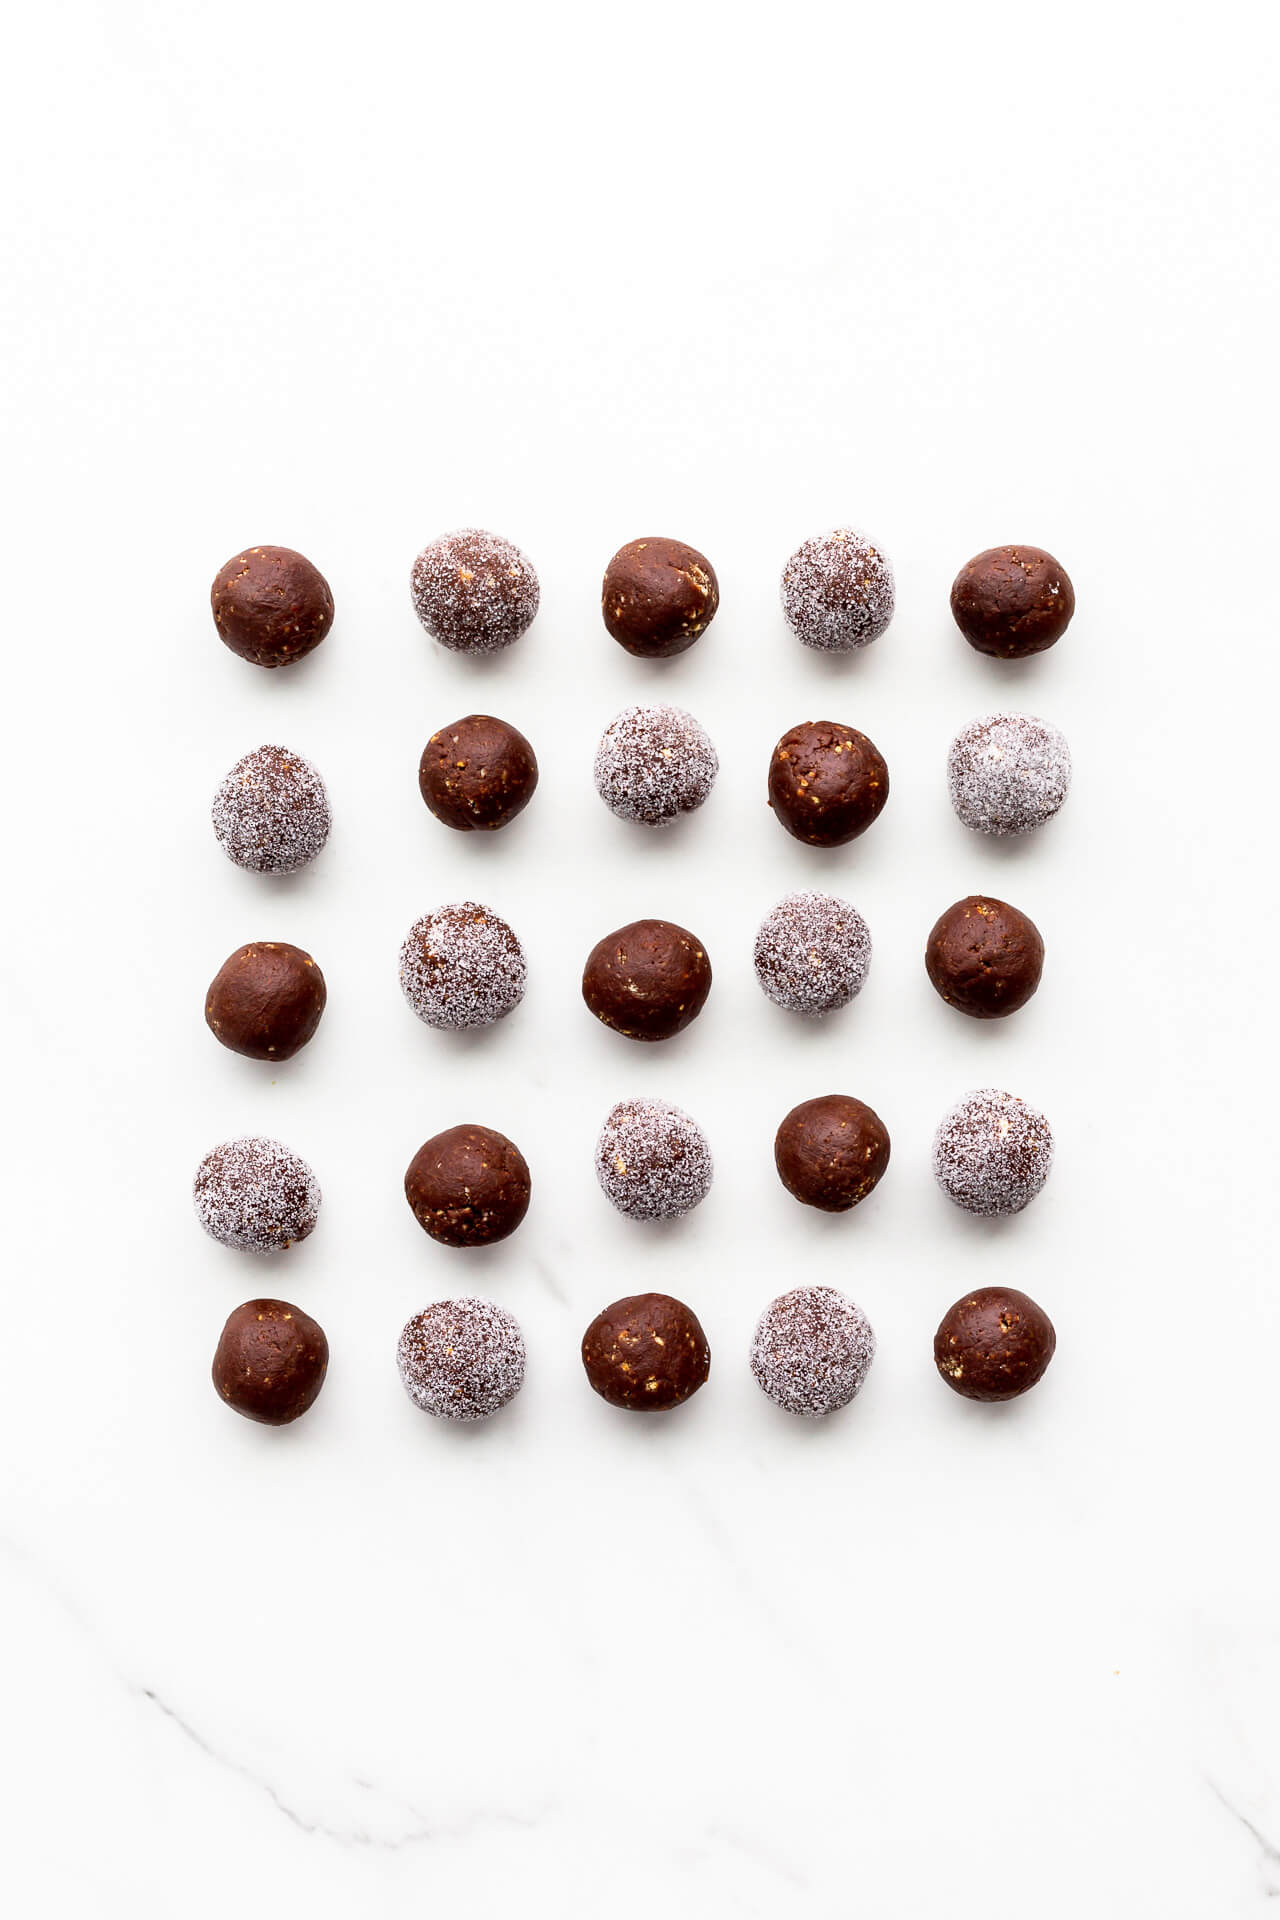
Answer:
[750,1286,875,1419]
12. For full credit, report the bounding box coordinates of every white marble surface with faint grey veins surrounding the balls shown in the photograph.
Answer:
[0,0,1280,1920]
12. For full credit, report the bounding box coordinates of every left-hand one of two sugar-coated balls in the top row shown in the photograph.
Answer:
[411,526,539,653]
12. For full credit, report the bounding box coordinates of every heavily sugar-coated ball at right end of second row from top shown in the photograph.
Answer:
[946,714,1071,835]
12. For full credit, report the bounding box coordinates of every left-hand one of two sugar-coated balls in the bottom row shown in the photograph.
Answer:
[395,1296,524,1421]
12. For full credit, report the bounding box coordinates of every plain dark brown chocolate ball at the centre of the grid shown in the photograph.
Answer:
[581,920,712,1041]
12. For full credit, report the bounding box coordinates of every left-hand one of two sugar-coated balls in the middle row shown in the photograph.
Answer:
[399,900,526,1027]
